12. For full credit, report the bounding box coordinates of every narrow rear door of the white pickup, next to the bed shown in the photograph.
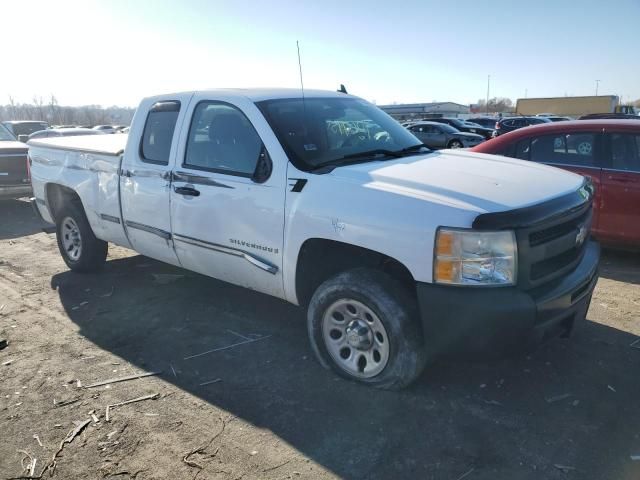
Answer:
[119,95,191,265]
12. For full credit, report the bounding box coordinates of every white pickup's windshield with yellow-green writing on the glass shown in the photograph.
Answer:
[257,97,421,171]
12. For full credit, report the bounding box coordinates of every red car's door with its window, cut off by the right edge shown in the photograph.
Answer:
[600,132,640,246]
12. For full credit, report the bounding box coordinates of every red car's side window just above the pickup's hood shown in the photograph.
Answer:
[529,133,597,167]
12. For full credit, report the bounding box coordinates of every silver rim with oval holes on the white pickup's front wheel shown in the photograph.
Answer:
[322,298,389,378]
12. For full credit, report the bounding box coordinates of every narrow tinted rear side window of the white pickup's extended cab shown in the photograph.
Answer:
[140,101,180,165]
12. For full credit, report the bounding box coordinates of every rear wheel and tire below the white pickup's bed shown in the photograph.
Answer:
[56,202,108,273]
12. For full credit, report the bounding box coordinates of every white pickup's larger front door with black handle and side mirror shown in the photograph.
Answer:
[171,95,286,297]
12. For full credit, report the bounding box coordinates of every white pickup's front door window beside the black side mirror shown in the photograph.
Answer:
[184,102,263,177]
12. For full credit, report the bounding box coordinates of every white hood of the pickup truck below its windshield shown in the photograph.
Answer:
[329,150,584,213]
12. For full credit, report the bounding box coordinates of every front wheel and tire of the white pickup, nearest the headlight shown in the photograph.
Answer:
[307,268,425,390]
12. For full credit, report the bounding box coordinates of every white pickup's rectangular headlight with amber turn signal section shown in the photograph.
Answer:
[433,228,518,286]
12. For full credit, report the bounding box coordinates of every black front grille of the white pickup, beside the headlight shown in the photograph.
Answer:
[516,202,592,289]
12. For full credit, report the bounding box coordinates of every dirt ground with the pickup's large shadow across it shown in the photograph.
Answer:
[0,197,640,480]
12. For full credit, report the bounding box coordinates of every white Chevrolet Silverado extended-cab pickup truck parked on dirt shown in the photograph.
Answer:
[29,90,599,389]
